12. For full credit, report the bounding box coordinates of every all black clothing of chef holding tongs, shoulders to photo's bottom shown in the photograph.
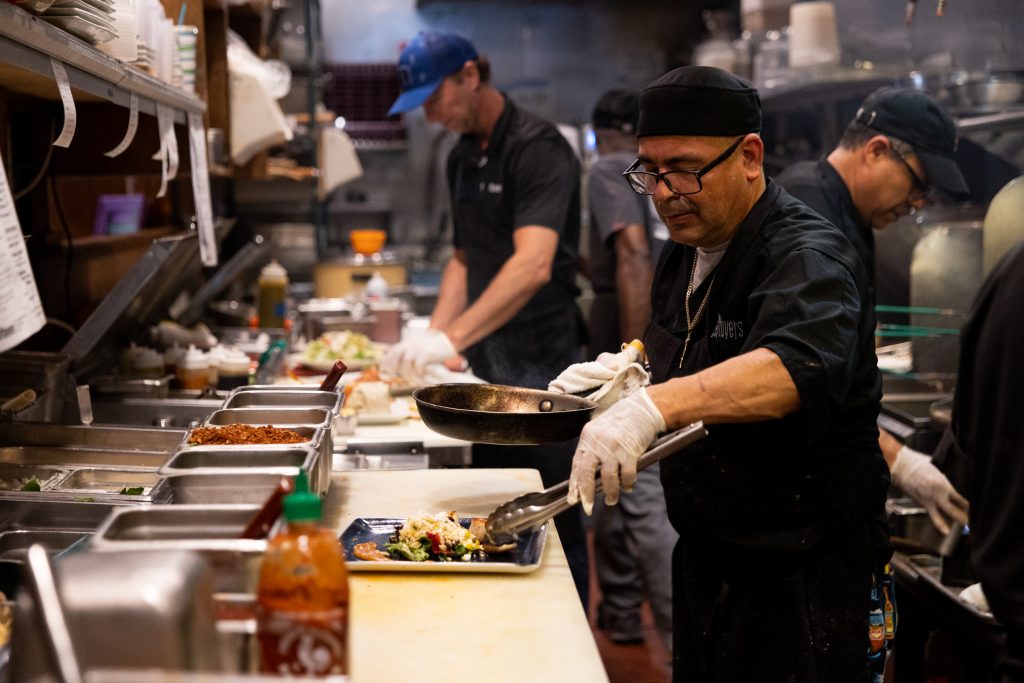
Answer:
[644,181,889,683]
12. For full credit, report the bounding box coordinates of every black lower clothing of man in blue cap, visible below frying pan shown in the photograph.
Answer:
[473,439,590,611]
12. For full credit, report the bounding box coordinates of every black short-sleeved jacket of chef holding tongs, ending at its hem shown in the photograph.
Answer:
[647,182,889,549]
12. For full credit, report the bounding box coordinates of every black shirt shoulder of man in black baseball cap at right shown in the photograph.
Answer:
[775,159,874,296]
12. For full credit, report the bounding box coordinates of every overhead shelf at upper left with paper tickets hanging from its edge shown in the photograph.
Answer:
[0,2,206,124]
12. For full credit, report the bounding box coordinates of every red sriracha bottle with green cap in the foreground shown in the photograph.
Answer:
[257,471,348,676]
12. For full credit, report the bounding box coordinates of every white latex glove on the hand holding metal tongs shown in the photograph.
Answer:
[568,389,666,515]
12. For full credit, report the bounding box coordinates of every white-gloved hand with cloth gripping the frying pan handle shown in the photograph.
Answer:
[548,341,650,417]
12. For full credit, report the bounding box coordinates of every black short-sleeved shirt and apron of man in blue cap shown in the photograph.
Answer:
[447,97,585,388]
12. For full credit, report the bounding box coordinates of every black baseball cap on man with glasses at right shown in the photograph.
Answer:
[854,86,971,196]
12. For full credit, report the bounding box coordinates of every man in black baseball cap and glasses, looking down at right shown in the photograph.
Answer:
[775,86,970,533]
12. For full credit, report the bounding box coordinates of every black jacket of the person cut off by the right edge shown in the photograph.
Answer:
[935,244,1024,681]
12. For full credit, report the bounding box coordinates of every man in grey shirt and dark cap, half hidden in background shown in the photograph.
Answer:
[581,88,676,652]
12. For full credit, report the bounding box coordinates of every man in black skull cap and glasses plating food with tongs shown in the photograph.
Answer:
[569,67,889,683]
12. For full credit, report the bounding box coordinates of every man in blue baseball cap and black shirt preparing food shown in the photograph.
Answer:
[382,31,587,604]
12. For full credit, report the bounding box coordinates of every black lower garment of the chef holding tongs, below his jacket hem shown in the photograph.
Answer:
[673,527,874,683]
